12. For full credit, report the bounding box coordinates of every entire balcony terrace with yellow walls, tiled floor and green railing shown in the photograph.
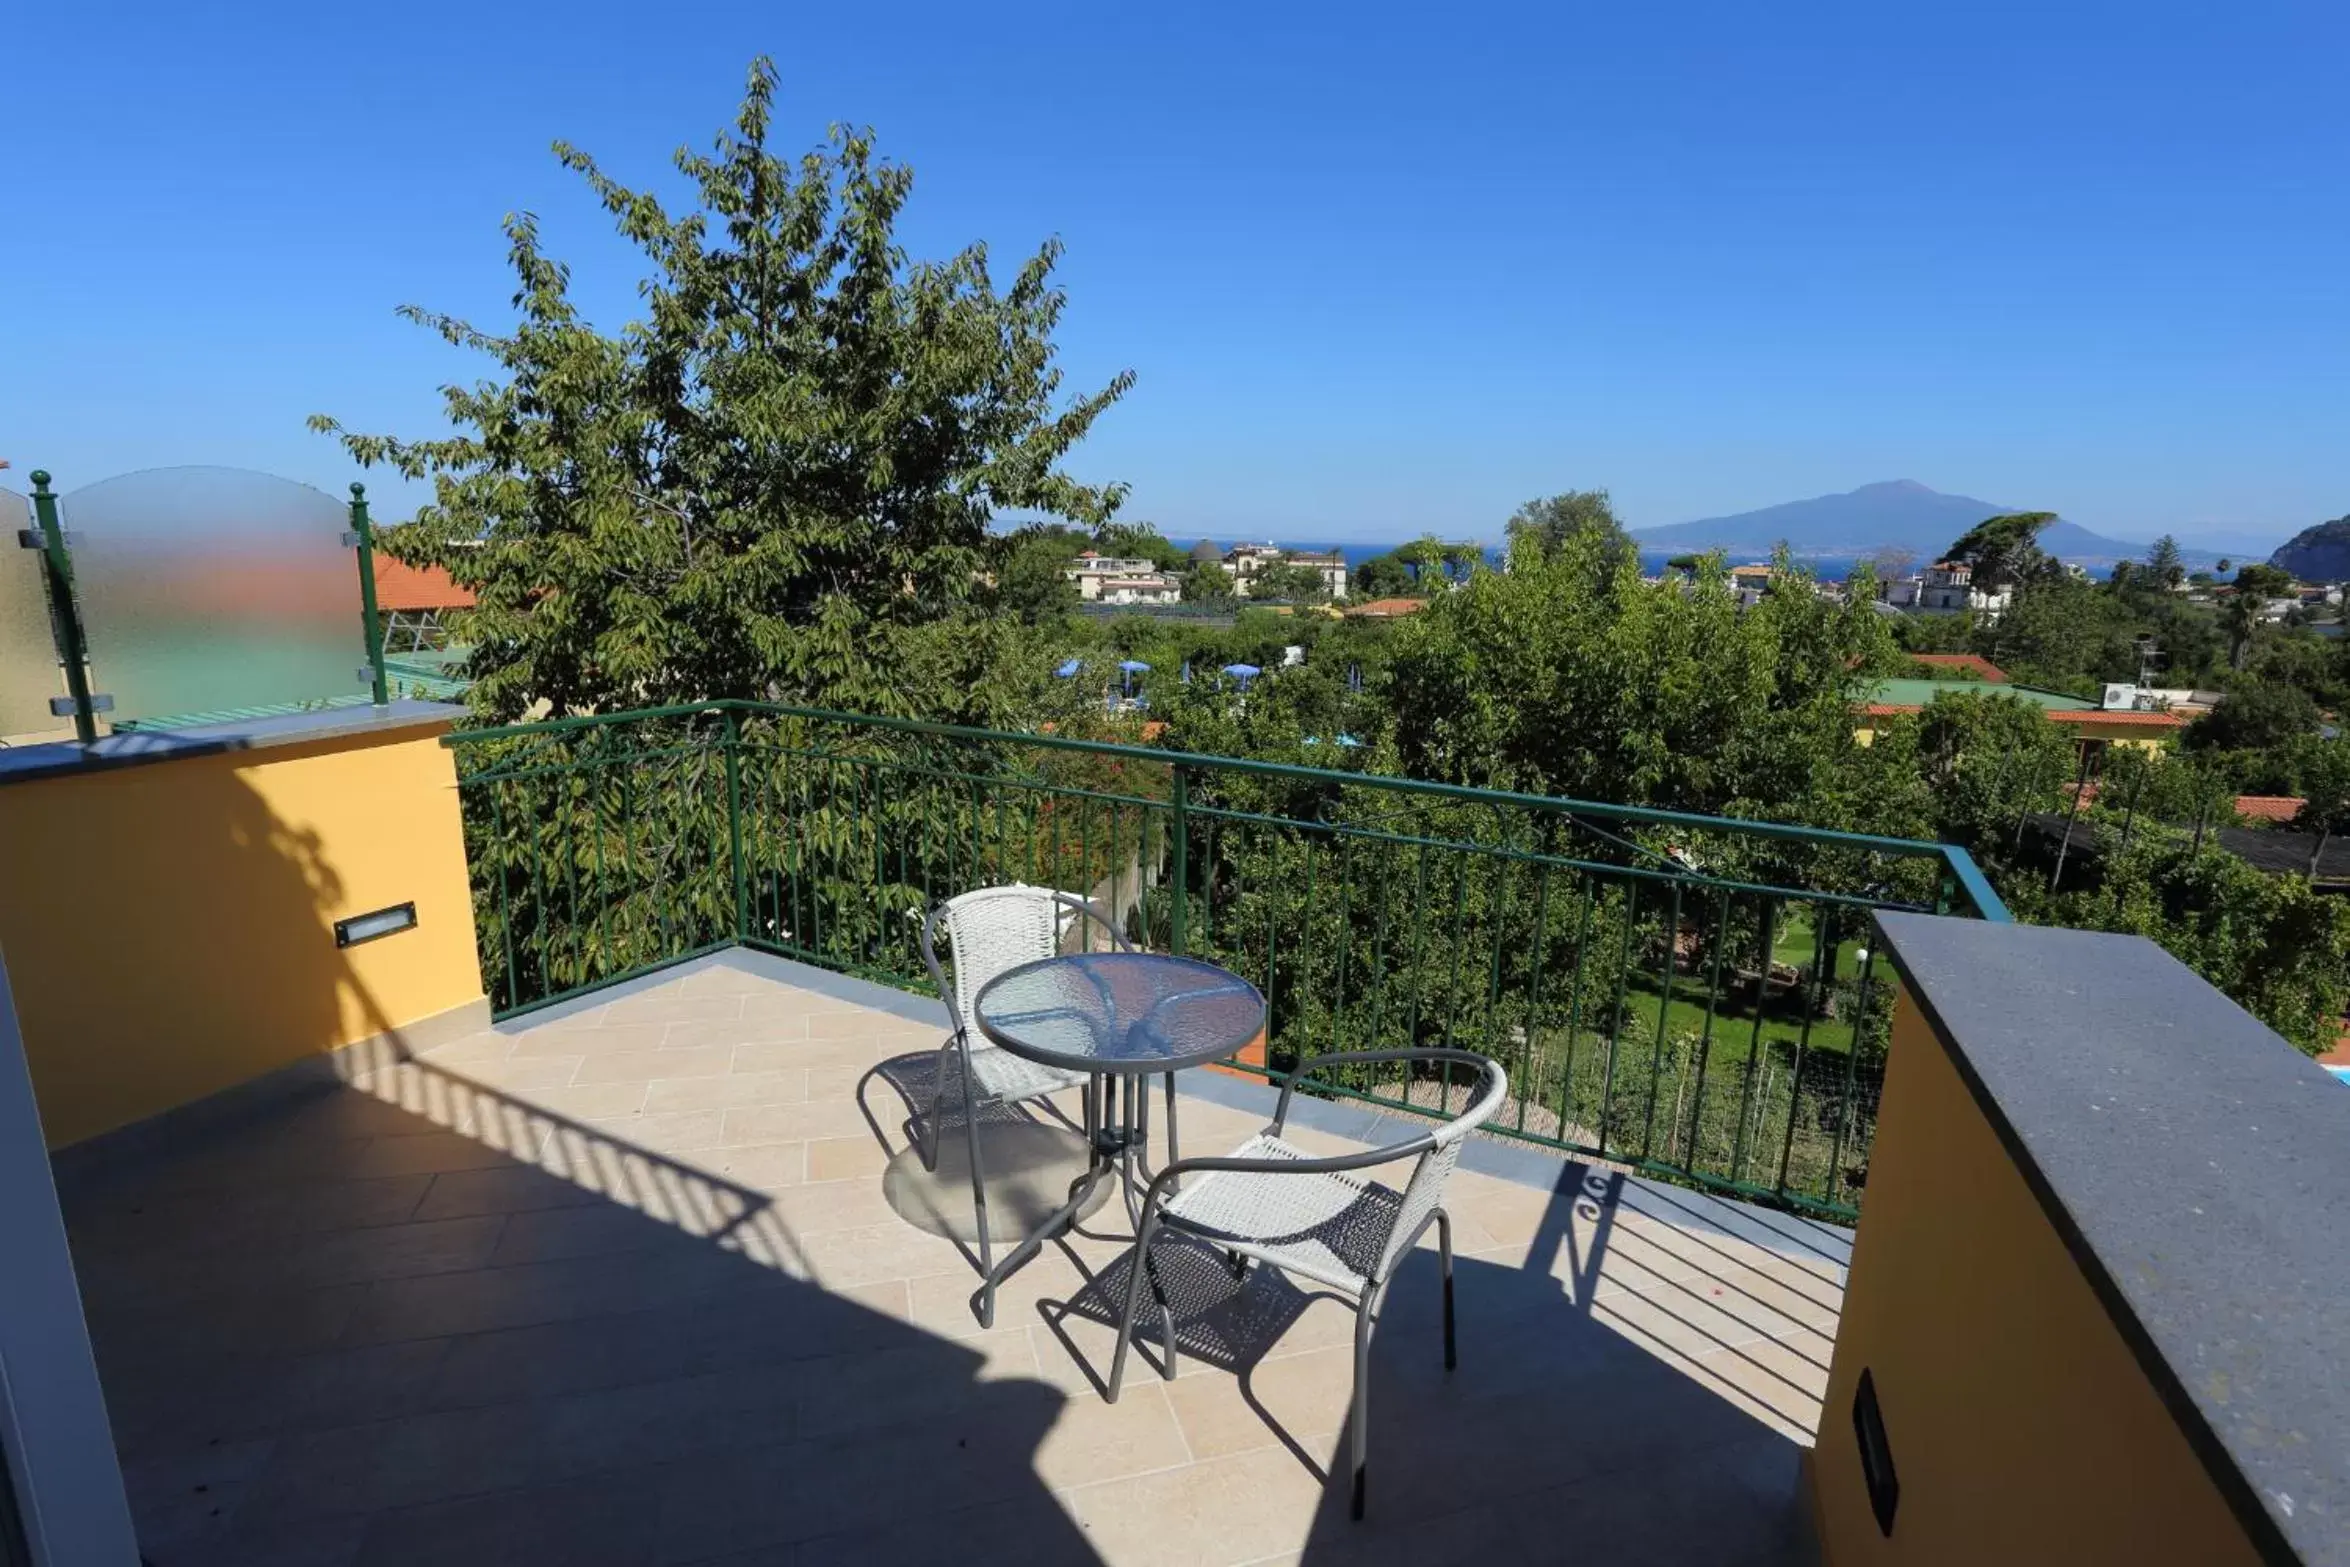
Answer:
[13,705,2350,1567]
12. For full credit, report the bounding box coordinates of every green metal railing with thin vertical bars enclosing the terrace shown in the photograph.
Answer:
[449,702,2007,1217]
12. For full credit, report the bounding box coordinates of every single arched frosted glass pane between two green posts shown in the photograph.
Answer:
[59,468,367,724]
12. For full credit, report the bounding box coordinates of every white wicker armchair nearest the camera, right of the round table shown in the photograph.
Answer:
[1109,1050,1509,1518]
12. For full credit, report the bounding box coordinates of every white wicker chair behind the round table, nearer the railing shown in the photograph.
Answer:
[921,883,1175,1327]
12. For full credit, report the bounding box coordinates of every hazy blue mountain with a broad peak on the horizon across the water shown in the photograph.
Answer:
[1633,479,2218,569]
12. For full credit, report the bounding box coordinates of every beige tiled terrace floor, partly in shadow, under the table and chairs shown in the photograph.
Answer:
[68,954,1845,1567]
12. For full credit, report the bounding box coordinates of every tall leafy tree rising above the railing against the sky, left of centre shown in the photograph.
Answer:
[313,59,1130,719]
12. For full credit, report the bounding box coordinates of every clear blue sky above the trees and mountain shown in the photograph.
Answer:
[0,0,2350,552]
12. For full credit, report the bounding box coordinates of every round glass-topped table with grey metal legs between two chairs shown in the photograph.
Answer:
[971,951,1264,1323]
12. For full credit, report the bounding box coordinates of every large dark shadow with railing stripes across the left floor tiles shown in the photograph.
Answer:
[55,1036,1118,1567]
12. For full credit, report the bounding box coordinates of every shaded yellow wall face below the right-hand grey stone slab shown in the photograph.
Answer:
[1812,996,2258,1567]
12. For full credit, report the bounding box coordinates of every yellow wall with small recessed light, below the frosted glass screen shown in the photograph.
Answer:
[0,721,482,1149]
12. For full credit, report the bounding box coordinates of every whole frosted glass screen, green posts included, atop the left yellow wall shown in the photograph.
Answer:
[0,468,390,740]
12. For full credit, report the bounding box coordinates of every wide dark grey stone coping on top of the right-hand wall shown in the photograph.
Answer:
[1878,914,2350,1567]
